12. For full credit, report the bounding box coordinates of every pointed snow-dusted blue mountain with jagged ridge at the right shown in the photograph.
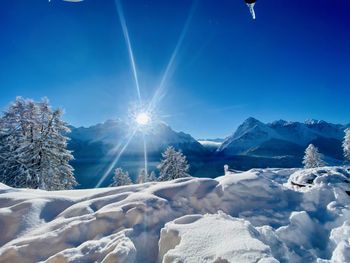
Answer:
[217,118,348,163]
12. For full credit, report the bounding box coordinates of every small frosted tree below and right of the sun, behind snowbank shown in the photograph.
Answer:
[158,146,189,181]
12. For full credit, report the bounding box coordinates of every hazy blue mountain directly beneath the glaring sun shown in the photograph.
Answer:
[68,120,209,188]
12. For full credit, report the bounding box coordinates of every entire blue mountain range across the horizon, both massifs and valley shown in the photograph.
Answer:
[69,118,347,188]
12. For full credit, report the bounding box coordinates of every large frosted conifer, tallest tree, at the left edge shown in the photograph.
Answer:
[0,97,77,190]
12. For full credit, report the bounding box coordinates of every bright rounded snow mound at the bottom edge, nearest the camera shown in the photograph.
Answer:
[159,213,278,263]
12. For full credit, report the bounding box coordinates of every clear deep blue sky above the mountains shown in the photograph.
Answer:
[0,0,350,138]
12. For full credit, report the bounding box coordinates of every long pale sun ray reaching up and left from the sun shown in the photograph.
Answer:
[115,0,142,103]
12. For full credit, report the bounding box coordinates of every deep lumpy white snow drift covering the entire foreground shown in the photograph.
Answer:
[0,167,350,263]
